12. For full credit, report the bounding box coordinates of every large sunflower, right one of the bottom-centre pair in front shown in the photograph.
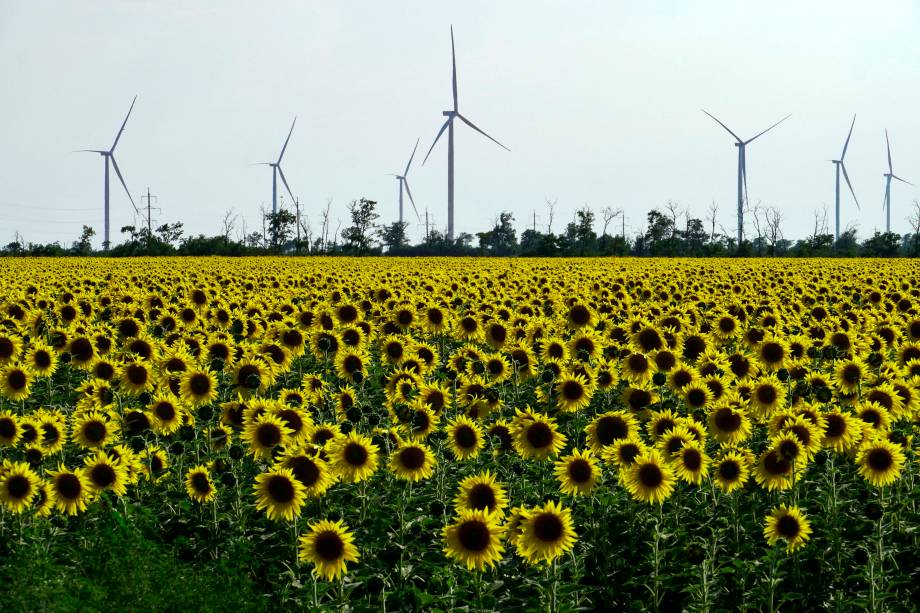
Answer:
[517,500,578,564]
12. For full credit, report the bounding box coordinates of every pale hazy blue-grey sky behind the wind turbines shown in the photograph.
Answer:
[0,0,920,245]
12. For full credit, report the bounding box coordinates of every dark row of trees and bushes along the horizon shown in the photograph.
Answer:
[0,198,920,257]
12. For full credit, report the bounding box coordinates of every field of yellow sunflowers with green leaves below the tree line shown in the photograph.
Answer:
[0,258,920,611]
